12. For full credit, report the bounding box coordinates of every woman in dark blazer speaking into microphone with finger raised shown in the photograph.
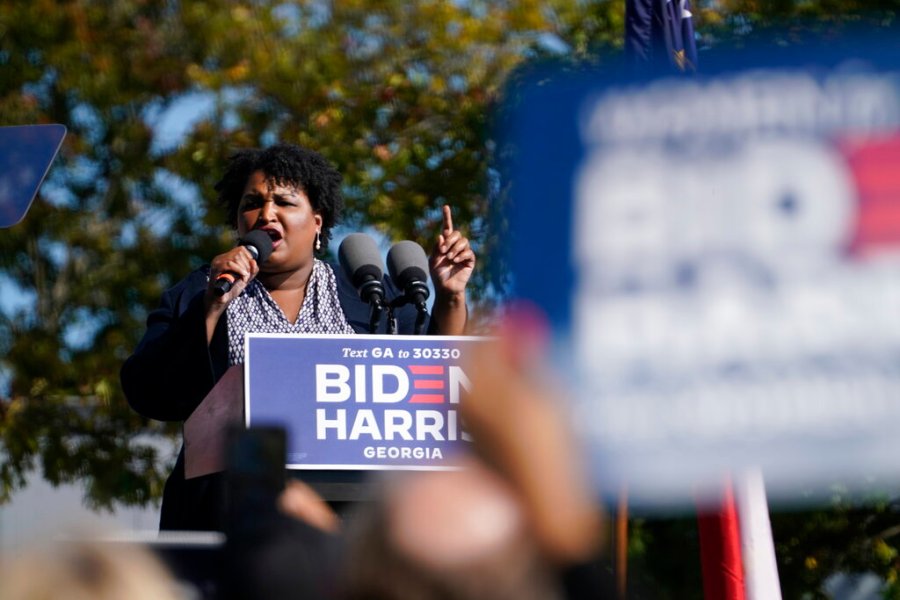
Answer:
[121,144,475,530]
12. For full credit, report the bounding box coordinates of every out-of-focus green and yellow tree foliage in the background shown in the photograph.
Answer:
[0,0,898,597]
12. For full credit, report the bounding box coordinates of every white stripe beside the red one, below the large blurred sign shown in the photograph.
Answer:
[734,469,781,600]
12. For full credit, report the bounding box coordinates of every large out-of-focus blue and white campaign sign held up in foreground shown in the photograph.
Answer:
[501,36,900,505]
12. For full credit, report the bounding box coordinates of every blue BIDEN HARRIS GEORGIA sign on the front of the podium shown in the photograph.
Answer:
[244,334,484,470]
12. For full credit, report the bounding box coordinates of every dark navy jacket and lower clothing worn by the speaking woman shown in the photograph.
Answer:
[121,265,434,530]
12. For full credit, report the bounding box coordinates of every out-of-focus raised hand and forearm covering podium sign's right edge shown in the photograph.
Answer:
[460,306,605,565]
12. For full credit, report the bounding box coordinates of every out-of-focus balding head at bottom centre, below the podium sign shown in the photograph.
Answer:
[347,454,559,600]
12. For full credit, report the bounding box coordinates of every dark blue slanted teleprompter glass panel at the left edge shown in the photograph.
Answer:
[0,125,66,227]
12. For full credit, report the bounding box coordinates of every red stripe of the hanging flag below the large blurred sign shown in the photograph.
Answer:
[697,482,746,600]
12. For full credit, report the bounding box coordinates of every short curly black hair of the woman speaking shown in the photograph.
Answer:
[215,144,344,252]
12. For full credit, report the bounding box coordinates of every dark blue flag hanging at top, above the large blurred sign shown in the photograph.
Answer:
[625,0,697,73]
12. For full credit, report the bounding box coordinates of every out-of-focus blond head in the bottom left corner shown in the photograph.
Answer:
[0,540,184,600]
